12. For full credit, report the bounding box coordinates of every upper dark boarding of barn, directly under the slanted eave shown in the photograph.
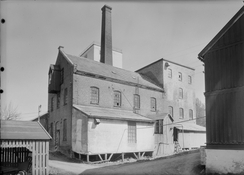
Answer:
[205,16,244,92]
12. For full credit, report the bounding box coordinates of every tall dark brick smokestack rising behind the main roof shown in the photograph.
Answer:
[100,5,113,65]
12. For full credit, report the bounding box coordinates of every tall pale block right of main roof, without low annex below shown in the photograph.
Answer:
[136,59,196,123]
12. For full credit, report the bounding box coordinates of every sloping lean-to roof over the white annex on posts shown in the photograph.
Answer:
[73,105,154,123]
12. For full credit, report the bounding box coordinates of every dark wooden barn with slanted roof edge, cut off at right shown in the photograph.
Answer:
[198,6,244,173]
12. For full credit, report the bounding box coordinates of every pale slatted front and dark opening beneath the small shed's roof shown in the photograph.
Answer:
[0,140,49,175]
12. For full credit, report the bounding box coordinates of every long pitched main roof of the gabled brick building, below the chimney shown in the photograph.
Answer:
[61,50,163,92]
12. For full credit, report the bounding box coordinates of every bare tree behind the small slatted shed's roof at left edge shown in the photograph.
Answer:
[1,102,21,120]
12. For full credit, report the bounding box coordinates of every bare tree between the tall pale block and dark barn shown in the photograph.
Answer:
[196,98,206,127]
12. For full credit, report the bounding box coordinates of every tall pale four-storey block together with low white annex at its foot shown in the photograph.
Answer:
[136,59,206,149]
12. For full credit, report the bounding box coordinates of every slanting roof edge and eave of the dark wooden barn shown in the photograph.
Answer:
[198,6,244,61]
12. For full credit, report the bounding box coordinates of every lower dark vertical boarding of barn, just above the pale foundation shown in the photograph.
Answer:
[205,87,244,145]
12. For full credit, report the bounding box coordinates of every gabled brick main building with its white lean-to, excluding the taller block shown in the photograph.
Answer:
[48,47,165,160]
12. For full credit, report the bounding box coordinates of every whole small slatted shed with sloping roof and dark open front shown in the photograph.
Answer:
[0,120,52,175]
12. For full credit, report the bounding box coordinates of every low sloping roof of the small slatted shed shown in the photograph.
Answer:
[1,120,52,140]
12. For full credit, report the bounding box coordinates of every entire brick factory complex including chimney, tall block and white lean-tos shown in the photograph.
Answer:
[48,6,204,161]
